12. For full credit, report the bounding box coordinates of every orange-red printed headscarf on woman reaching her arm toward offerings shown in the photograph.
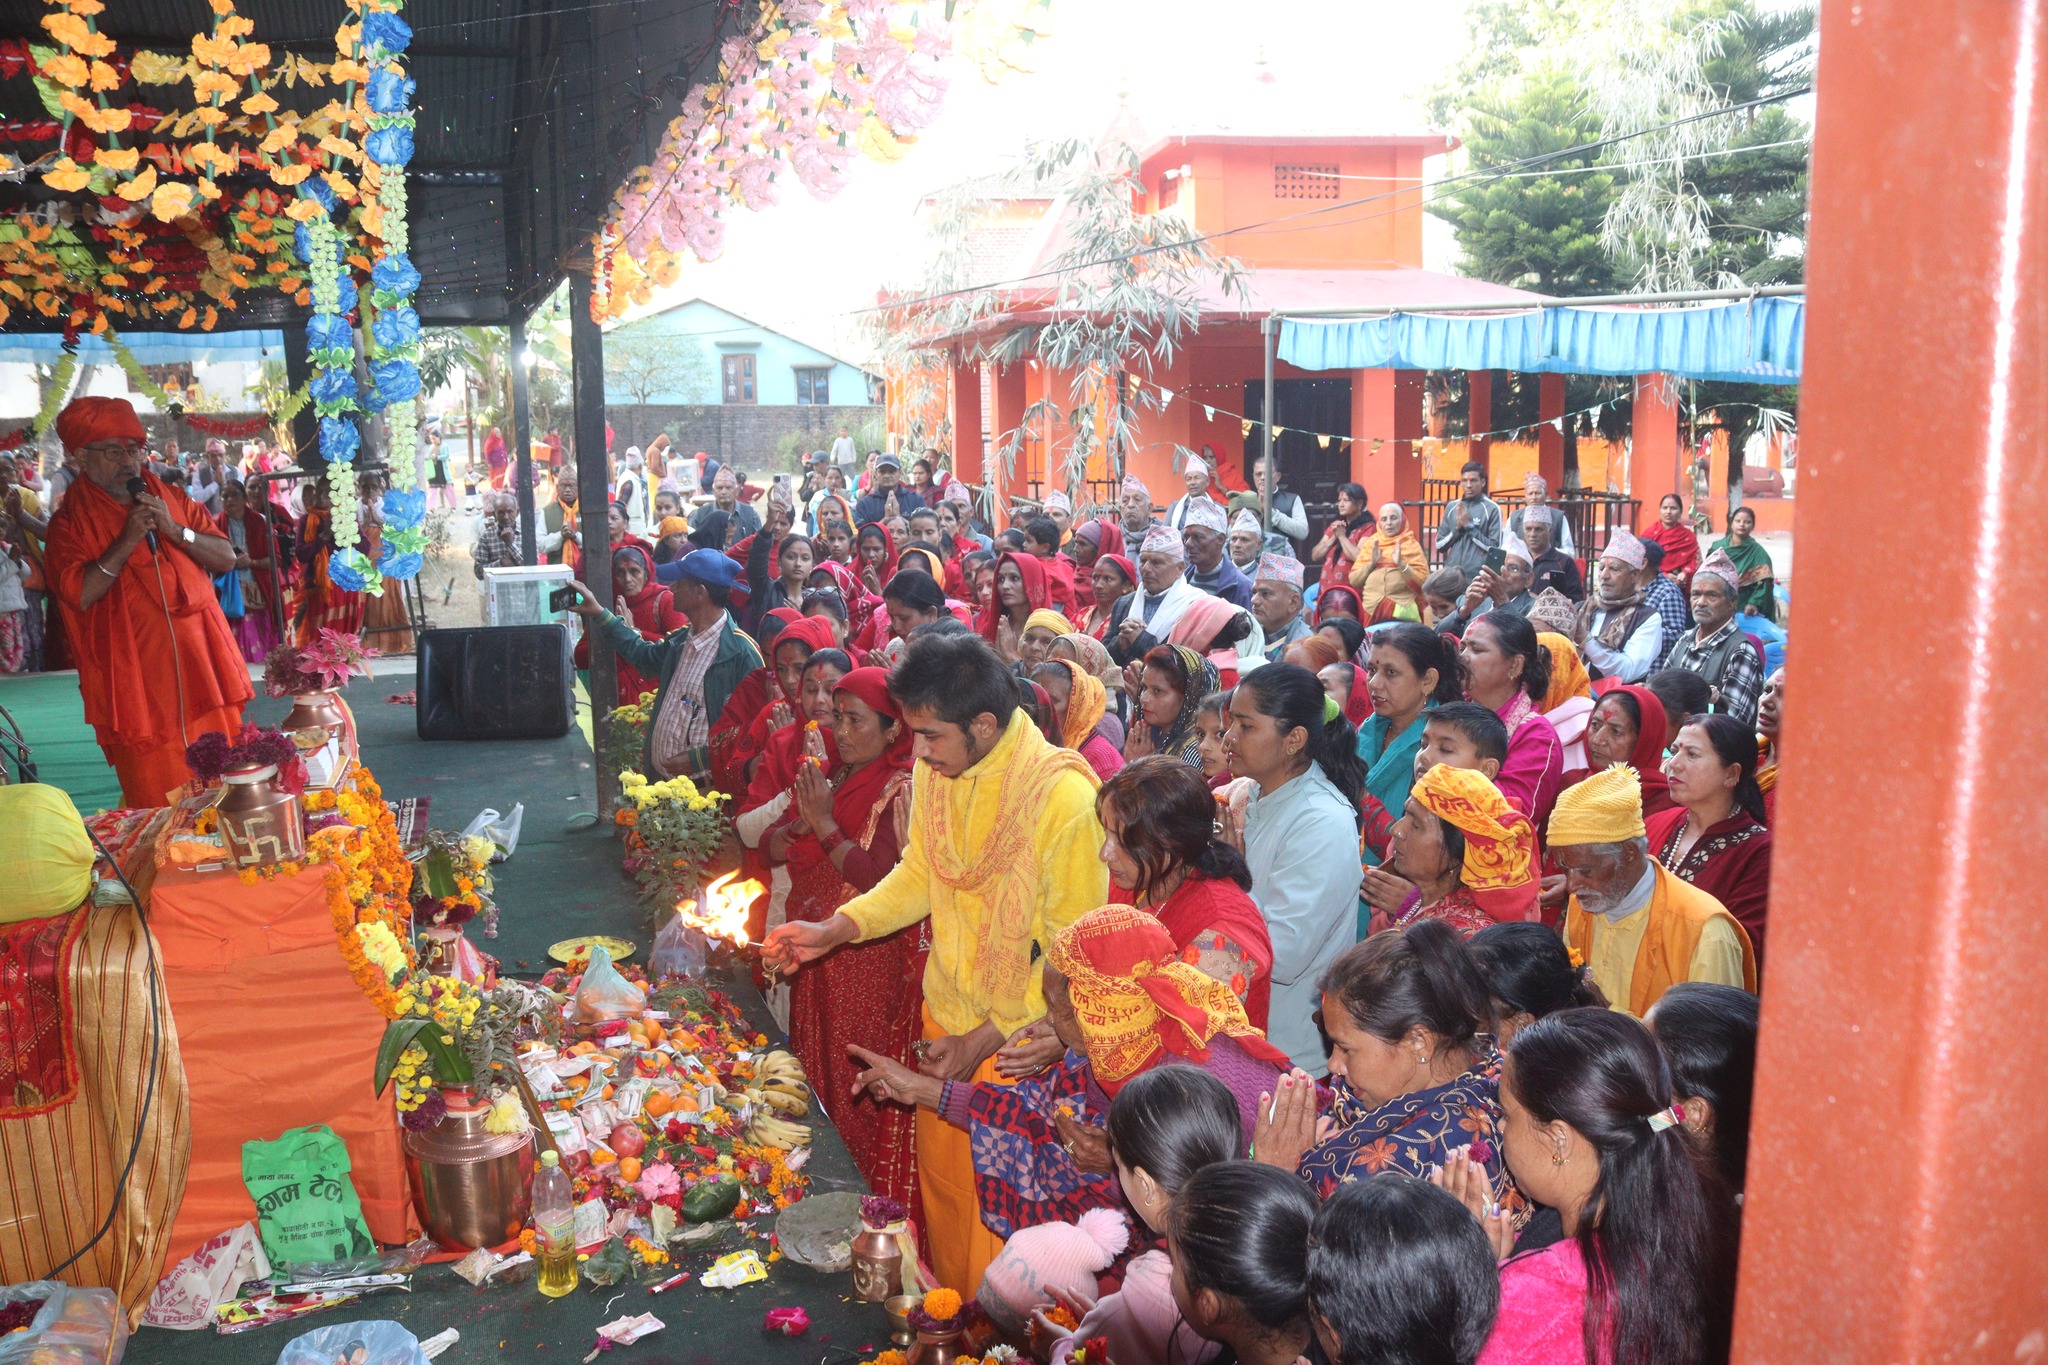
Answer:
[1047,905,1288,1095]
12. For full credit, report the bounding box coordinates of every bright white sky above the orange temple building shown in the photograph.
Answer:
[614,0,1464,360]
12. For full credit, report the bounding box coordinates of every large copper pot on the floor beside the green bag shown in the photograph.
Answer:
[403,1085,532,1250]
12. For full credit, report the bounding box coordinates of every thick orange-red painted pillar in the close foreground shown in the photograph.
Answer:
[1735,0,2048,1363]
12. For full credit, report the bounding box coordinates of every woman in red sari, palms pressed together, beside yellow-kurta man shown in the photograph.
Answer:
[768,669,928,1207]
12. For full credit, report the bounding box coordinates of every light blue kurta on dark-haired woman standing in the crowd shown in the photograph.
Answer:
[1245,763,1358,1076]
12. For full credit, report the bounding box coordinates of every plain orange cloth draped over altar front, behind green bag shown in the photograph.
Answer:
[150,866,416,1267]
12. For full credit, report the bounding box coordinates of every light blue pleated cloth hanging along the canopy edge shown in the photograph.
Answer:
[1278,297,1806,385]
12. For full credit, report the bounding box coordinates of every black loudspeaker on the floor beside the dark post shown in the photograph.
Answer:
[416,626,575,739]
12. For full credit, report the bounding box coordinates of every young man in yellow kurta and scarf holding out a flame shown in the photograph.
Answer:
[764,634,1108,1295]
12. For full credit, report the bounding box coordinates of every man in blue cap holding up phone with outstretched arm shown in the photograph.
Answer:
[571,551,762,784]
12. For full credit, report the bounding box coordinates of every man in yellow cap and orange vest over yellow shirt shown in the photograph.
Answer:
[1550,763,1757,1019]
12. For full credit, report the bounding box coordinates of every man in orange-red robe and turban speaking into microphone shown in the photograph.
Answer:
[45,397,256,806]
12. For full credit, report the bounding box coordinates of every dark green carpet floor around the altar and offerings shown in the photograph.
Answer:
[61,675,889,1365]
